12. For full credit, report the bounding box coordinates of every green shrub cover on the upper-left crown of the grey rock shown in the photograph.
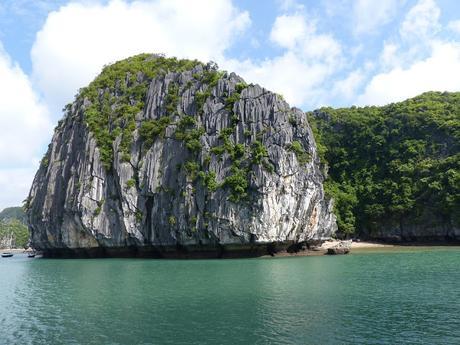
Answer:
[78,54,200,170]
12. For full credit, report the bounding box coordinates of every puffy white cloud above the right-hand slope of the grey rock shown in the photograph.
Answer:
[222,13,342,107]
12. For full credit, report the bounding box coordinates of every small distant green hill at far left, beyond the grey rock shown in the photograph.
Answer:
[0,207,29,248]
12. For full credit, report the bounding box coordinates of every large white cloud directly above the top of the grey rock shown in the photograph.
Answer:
[31,0,250,115]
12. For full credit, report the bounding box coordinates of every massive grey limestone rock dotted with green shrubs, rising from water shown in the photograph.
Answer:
[27,55,336,256]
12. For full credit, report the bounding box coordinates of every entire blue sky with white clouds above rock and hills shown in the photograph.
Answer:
[0,0,460,210]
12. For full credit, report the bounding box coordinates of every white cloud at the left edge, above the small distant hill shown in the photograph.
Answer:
[0,44,51,209]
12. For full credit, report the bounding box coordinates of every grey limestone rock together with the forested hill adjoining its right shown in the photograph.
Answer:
[20,54,460,257]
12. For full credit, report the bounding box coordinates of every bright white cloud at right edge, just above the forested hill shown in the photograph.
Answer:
[357,41,460,105]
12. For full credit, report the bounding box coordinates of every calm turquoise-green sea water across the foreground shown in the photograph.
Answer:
[0,248,460,345]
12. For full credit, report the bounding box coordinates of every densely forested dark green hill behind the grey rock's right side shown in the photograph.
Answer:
[307,92,460,240]
